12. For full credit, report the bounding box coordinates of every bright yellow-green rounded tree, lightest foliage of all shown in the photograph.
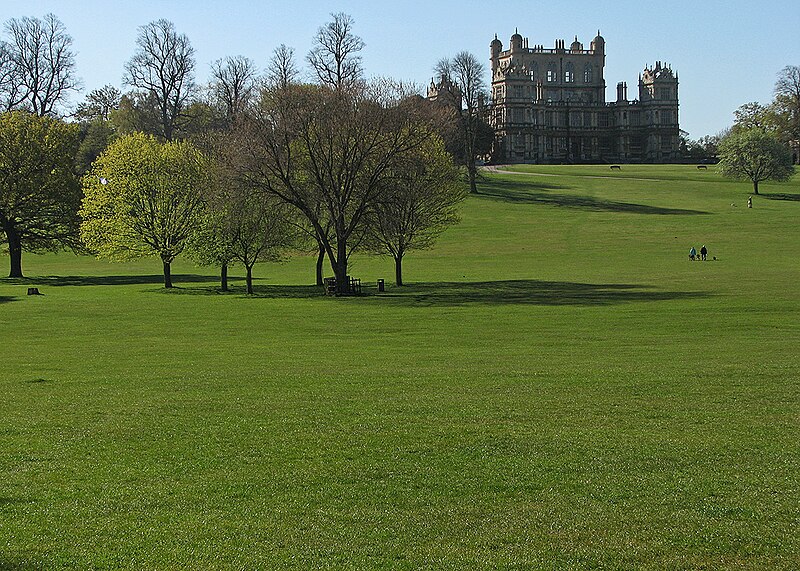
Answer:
[80,133,210,288]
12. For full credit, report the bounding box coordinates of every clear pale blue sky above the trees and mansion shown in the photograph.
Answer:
[0,0,800,138]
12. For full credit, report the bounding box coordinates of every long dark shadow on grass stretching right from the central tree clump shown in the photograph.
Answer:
[379,280,709,306]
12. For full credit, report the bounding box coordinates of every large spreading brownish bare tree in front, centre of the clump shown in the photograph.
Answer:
[235,85,431,294]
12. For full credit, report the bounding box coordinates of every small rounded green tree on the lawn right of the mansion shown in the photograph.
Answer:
[719,128,794,194]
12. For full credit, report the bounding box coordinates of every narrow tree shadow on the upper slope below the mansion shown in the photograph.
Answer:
[478,181,708,216]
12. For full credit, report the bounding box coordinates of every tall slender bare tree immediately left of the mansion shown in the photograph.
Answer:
[435,51,486,193]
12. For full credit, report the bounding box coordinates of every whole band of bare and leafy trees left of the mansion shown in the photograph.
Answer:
[0,14,474,293]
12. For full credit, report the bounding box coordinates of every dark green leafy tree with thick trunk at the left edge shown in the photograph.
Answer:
[0,111,81,278]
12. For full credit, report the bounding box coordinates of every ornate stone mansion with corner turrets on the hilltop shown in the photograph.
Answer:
[490,32,679,163]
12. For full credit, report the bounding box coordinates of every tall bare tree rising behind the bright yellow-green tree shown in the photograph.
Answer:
[125,19,195,141]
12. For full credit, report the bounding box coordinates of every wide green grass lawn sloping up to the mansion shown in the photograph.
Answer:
[0,165,800,571]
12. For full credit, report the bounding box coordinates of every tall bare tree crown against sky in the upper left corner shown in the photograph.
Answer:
[0,14,79,116]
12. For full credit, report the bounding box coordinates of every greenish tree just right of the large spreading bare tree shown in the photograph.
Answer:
[369,137,466,286]
